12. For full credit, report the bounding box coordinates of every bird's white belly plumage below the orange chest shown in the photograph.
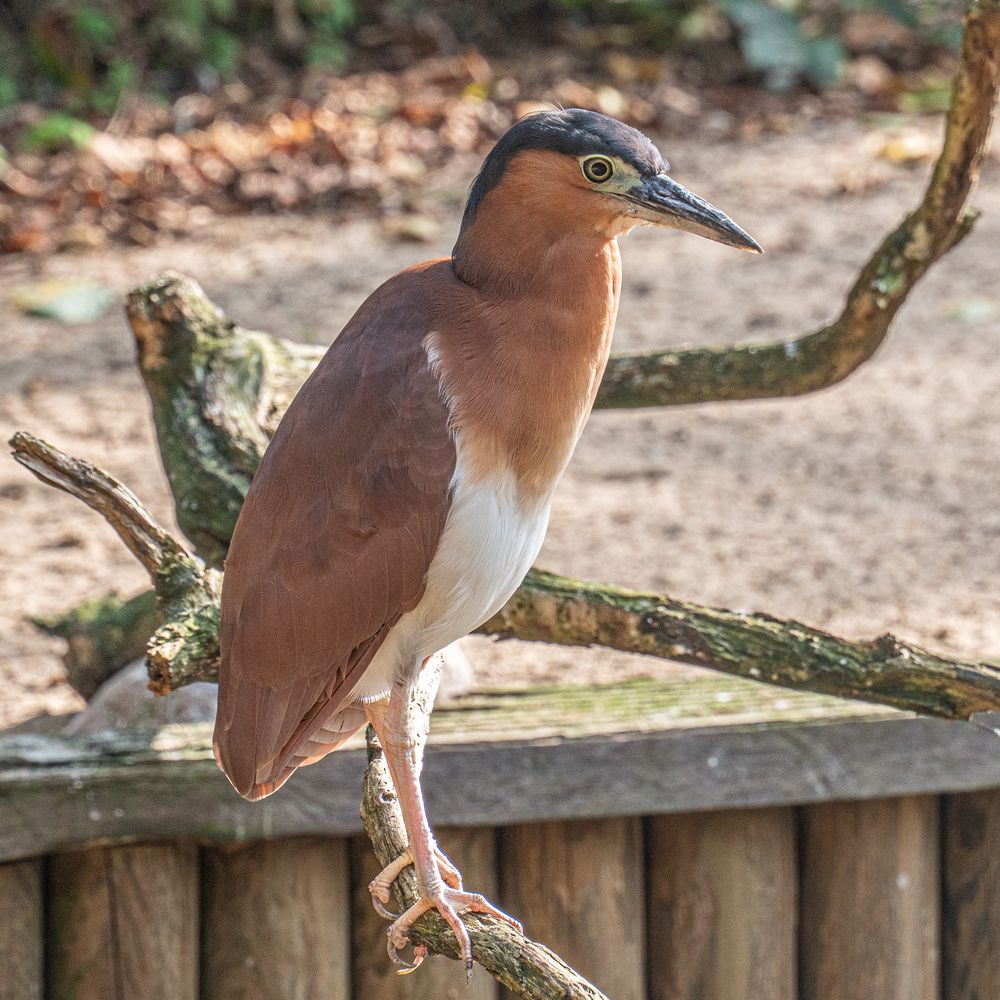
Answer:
[353,447,551,699]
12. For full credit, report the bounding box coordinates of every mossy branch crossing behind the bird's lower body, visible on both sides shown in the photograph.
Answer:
[11,434,1000,719]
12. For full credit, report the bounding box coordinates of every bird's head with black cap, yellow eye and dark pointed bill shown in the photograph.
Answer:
[460,108,763,253]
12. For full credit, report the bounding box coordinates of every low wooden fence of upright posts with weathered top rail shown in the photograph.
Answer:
[0,677,1000,1000]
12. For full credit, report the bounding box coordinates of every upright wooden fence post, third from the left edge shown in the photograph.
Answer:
[201,838,351,1000]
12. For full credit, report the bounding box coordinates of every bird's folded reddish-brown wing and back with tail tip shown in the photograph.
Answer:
[215,263,455,799]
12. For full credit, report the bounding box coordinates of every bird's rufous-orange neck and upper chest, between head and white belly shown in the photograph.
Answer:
[434,201,621,502]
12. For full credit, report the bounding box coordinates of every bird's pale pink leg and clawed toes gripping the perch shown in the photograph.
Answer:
[365,681,520,976]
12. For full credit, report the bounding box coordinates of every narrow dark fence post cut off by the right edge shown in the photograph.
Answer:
[942,791,1000,1000]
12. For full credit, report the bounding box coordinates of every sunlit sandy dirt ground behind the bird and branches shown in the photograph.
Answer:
[0,122,1000,726]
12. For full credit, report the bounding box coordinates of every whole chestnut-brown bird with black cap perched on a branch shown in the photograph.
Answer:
[215,110,760,970]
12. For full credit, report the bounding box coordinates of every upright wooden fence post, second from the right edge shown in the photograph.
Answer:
[800,797,940,1000]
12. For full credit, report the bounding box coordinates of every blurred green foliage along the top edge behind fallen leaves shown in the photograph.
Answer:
[0,0,960,112]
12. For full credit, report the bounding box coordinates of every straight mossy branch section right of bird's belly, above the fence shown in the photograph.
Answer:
[481,571,1000,719]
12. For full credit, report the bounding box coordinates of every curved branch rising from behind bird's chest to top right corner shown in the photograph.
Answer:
[597,0,1000,408]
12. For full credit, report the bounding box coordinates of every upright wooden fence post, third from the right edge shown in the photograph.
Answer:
[646,808,798,1000]
